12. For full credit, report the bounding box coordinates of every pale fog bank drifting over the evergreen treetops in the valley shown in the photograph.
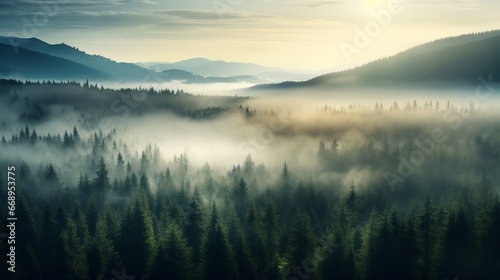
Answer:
[0,79,500,201]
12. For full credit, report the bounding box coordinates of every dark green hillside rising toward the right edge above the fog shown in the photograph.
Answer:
[254,30,500,89]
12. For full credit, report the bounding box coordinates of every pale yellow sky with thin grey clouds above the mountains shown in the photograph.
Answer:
[0,0,500,70]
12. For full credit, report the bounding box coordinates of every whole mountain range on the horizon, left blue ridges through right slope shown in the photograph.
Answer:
[0,30,500,89]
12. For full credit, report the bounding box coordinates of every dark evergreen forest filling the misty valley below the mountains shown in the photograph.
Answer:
[0,81,500,279]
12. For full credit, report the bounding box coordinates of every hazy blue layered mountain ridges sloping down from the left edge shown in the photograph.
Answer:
[0,36,269,84]
